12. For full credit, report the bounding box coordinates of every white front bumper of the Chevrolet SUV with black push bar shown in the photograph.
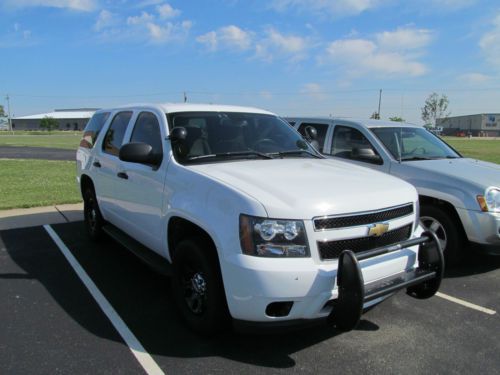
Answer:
[222,233,444,329]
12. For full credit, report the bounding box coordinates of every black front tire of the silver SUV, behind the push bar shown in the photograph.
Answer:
[420,204,466,264]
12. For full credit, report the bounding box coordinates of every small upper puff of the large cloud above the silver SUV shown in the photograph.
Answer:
[375,27,433,51]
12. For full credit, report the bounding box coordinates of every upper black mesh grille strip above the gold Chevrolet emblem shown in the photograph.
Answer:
[314,204,413,230]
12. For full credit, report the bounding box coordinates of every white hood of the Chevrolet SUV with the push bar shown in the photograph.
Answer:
[188,158,417,220]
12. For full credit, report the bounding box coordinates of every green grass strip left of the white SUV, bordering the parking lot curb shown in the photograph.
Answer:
[0,159,81,210]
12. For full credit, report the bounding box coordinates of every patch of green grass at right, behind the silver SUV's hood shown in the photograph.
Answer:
[443,137,500,164]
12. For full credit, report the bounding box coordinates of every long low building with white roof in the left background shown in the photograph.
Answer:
[12,108,97,130]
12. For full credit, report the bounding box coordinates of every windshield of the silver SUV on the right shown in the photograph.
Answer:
[370,127,461,161]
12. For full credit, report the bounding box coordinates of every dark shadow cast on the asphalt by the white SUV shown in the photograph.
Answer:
[0,222,379,370]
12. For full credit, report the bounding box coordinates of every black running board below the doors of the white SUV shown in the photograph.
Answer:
[102,224,172,276]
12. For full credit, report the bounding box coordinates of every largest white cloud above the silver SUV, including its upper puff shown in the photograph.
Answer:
[320,27,432,77]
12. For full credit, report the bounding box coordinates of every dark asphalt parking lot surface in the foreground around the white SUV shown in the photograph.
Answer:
[0,222,500,374]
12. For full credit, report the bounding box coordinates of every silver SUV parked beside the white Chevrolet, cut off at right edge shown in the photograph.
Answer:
[287,117,500,263]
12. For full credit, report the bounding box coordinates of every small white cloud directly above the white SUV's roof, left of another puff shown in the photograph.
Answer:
[196,25,252,51]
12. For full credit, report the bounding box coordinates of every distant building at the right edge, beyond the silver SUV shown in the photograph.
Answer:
[436,113,500,137]
